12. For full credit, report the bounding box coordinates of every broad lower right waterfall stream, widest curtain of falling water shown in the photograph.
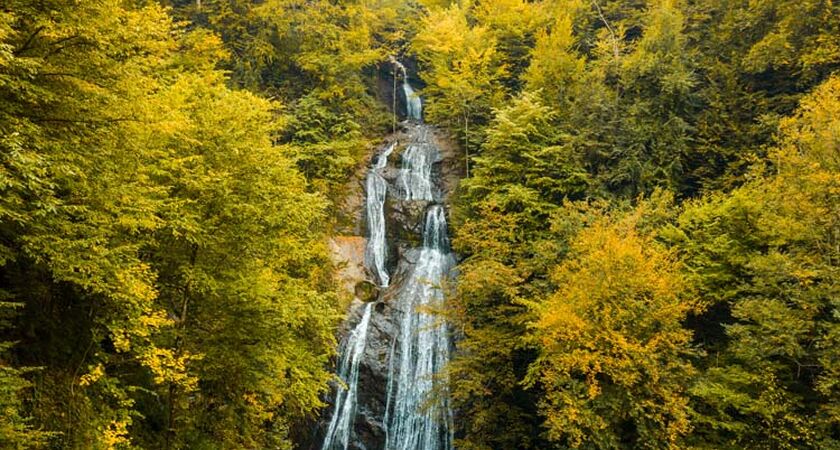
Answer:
[385,205,454,450]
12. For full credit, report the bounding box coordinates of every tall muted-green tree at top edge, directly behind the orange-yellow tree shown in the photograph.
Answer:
[595,0,695,197]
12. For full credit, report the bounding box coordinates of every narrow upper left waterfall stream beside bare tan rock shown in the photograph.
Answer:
[365,142,397,287]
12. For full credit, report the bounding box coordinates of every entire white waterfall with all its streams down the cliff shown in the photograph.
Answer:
[322,72,454,450]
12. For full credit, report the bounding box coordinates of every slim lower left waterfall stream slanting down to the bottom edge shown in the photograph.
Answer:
[321,303,373,450]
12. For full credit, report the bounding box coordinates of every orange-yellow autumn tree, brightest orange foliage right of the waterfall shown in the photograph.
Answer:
[530,198,699,448]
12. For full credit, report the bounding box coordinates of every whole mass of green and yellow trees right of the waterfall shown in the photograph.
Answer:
[424,0,840,449]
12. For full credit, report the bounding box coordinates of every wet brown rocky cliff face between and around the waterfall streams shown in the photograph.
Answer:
[310,119,460,450]
